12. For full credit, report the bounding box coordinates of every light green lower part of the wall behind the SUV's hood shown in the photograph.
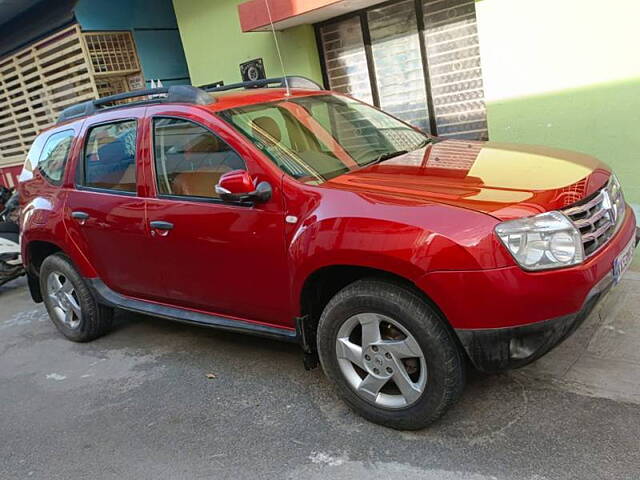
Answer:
[487,77,640,206]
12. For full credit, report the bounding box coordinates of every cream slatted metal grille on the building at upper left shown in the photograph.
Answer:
[0,25,140,165]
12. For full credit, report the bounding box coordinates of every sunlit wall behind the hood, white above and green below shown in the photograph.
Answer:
[476,0,640,213]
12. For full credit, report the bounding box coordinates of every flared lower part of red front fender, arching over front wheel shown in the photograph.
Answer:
[288,212,502,316]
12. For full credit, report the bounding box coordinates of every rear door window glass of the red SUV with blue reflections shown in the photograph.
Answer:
[83,120,136,192]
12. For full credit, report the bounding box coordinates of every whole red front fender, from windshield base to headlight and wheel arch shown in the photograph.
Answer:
[283,178,513,311]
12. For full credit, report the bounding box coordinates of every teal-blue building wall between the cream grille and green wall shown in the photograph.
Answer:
[75,0,190,86]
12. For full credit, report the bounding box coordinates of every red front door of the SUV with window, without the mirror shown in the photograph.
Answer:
[147,107,291,326]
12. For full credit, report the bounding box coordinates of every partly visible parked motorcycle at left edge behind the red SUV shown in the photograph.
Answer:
[0,191,25,285]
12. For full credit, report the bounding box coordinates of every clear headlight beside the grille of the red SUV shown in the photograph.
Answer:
[496,212,584,270]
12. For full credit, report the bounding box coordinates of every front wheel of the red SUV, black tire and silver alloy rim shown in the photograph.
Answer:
[317,279,465,430]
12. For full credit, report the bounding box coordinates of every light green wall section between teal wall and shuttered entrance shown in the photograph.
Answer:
[173,0,322,85]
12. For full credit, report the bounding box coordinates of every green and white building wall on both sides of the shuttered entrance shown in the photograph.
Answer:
[173,0,640,210]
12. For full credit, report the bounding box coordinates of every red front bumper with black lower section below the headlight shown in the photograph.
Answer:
[419,209,640,372]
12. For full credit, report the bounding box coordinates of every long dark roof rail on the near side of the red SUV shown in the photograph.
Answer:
[56,85,215,123]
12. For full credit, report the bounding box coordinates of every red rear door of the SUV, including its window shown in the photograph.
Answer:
[65,108,162,298]
